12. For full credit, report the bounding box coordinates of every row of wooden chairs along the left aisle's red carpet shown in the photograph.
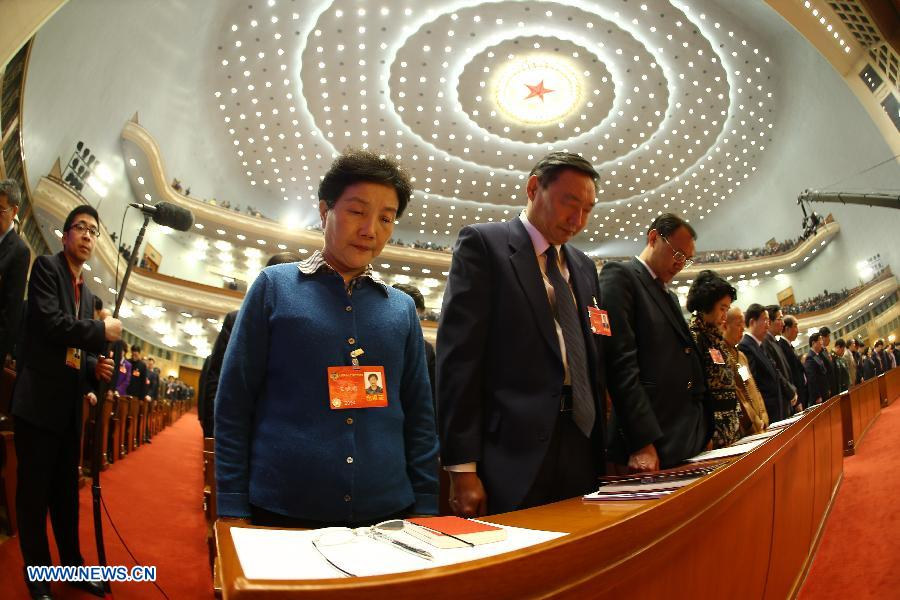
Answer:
[0,369,191,535]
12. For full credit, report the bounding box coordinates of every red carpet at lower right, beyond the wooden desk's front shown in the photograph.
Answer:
[799,400,900,600]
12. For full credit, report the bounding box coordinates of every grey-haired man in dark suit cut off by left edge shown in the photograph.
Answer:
[0,179,31,368]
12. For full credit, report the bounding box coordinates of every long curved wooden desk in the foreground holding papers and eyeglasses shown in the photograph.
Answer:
[216,398,843,600]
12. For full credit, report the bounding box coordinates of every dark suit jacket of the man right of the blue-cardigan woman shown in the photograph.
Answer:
[436,219,605,512]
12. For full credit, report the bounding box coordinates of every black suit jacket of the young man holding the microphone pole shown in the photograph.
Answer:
[12,252,106,432]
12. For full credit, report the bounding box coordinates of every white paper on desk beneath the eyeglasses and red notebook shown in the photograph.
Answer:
[231,525,566,580]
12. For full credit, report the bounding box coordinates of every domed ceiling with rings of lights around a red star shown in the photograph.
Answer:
[213,0,777,250]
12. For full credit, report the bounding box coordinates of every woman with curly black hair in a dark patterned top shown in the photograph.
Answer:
[687,271,741,448]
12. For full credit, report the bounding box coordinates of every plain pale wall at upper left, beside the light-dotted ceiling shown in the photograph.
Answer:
[23,2,263,253]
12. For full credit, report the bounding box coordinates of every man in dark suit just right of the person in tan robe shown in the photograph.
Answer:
[738,303,791,423]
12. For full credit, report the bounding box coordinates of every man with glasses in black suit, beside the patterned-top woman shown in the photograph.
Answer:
[600,213,711,471]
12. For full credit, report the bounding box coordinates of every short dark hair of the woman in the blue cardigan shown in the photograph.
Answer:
[319,149,412,219]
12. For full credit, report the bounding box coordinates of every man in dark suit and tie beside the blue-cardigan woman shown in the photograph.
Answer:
[437,152,605,517]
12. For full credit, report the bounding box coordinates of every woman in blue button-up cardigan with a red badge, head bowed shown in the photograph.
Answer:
[215,150,438,527]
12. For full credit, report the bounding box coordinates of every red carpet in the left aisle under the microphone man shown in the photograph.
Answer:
[0,412,213,600]
